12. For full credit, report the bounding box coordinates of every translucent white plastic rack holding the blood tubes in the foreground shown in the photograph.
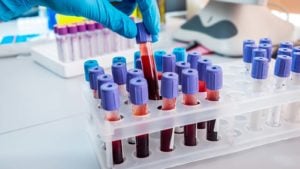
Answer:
[83,61,300,169]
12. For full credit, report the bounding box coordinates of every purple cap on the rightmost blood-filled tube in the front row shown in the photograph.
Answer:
[205,66,223,90]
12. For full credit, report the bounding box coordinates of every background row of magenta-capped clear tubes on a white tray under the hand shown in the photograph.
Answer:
[54,21,135,63]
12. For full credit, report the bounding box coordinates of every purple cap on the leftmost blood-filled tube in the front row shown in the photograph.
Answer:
[100,82,120,111]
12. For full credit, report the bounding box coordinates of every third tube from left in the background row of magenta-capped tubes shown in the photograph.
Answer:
[77,23,89,59]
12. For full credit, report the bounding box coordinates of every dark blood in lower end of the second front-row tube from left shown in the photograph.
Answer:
[135,134,149,158]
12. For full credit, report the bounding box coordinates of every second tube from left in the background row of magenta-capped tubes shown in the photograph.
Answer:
[68,25,81,61]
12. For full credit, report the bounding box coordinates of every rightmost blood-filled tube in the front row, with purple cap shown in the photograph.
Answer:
[206,66,223,141]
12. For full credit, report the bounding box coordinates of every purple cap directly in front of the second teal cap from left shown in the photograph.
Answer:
[111,62,127,85]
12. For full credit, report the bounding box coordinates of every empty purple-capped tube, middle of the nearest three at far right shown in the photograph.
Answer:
[267,55,292,127]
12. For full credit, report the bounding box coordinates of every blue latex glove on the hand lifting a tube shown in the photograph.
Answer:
[0,0,160,41]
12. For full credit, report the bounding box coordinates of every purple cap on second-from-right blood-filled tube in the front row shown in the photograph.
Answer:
[178,68,199,94]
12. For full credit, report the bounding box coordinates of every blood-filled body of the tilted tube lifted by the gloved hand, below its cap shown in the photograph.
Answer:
[140,42,160,100]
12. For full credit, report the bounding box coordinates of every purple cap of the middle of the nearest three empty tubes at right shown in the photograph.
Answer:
[274,55,292,77]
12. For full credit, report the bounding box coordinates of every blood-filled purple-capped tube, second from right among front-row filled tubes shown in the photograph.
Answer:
[182,68,198,146]
